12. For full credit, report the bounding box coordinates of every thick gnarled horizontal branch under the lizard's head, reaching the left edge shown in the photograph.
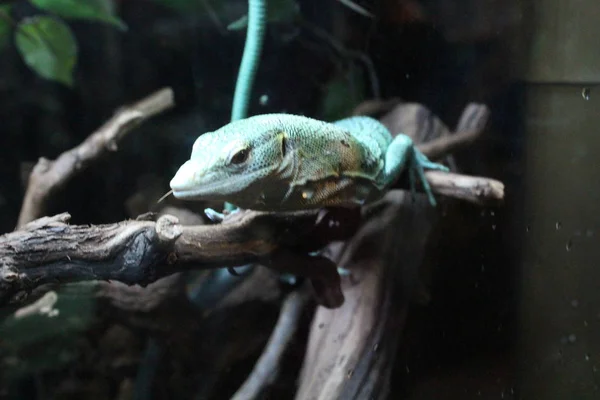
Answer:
[0,210,358,306]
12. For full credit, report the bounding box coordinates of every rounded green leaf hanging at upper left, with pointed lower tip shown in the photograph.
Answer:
[15,17,77,86]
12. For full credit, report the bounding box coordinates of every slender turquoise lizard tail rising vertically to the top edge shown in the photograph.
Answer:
[231,0,266,121]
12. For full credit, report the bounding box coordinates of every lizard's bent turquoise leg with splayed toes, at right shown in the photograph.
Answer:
[384,134,449,206]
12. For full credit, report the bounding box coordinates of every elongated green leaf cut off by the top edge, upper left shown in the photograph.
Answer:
[30,0,127,30]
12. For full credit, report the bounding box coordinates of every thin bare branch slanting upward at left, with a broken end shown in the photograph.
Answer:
[17,88,175,227]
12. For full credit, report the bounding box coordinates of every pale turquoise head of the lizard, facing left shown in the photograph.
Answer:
[170,116,285,206]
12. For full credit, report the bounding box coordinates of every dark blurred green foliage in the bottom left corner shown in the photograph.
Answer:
[0,285,95,380]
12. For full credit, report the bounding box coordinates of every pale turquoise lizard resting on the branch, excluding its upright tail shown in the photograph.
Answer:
[170,114,448,211]
